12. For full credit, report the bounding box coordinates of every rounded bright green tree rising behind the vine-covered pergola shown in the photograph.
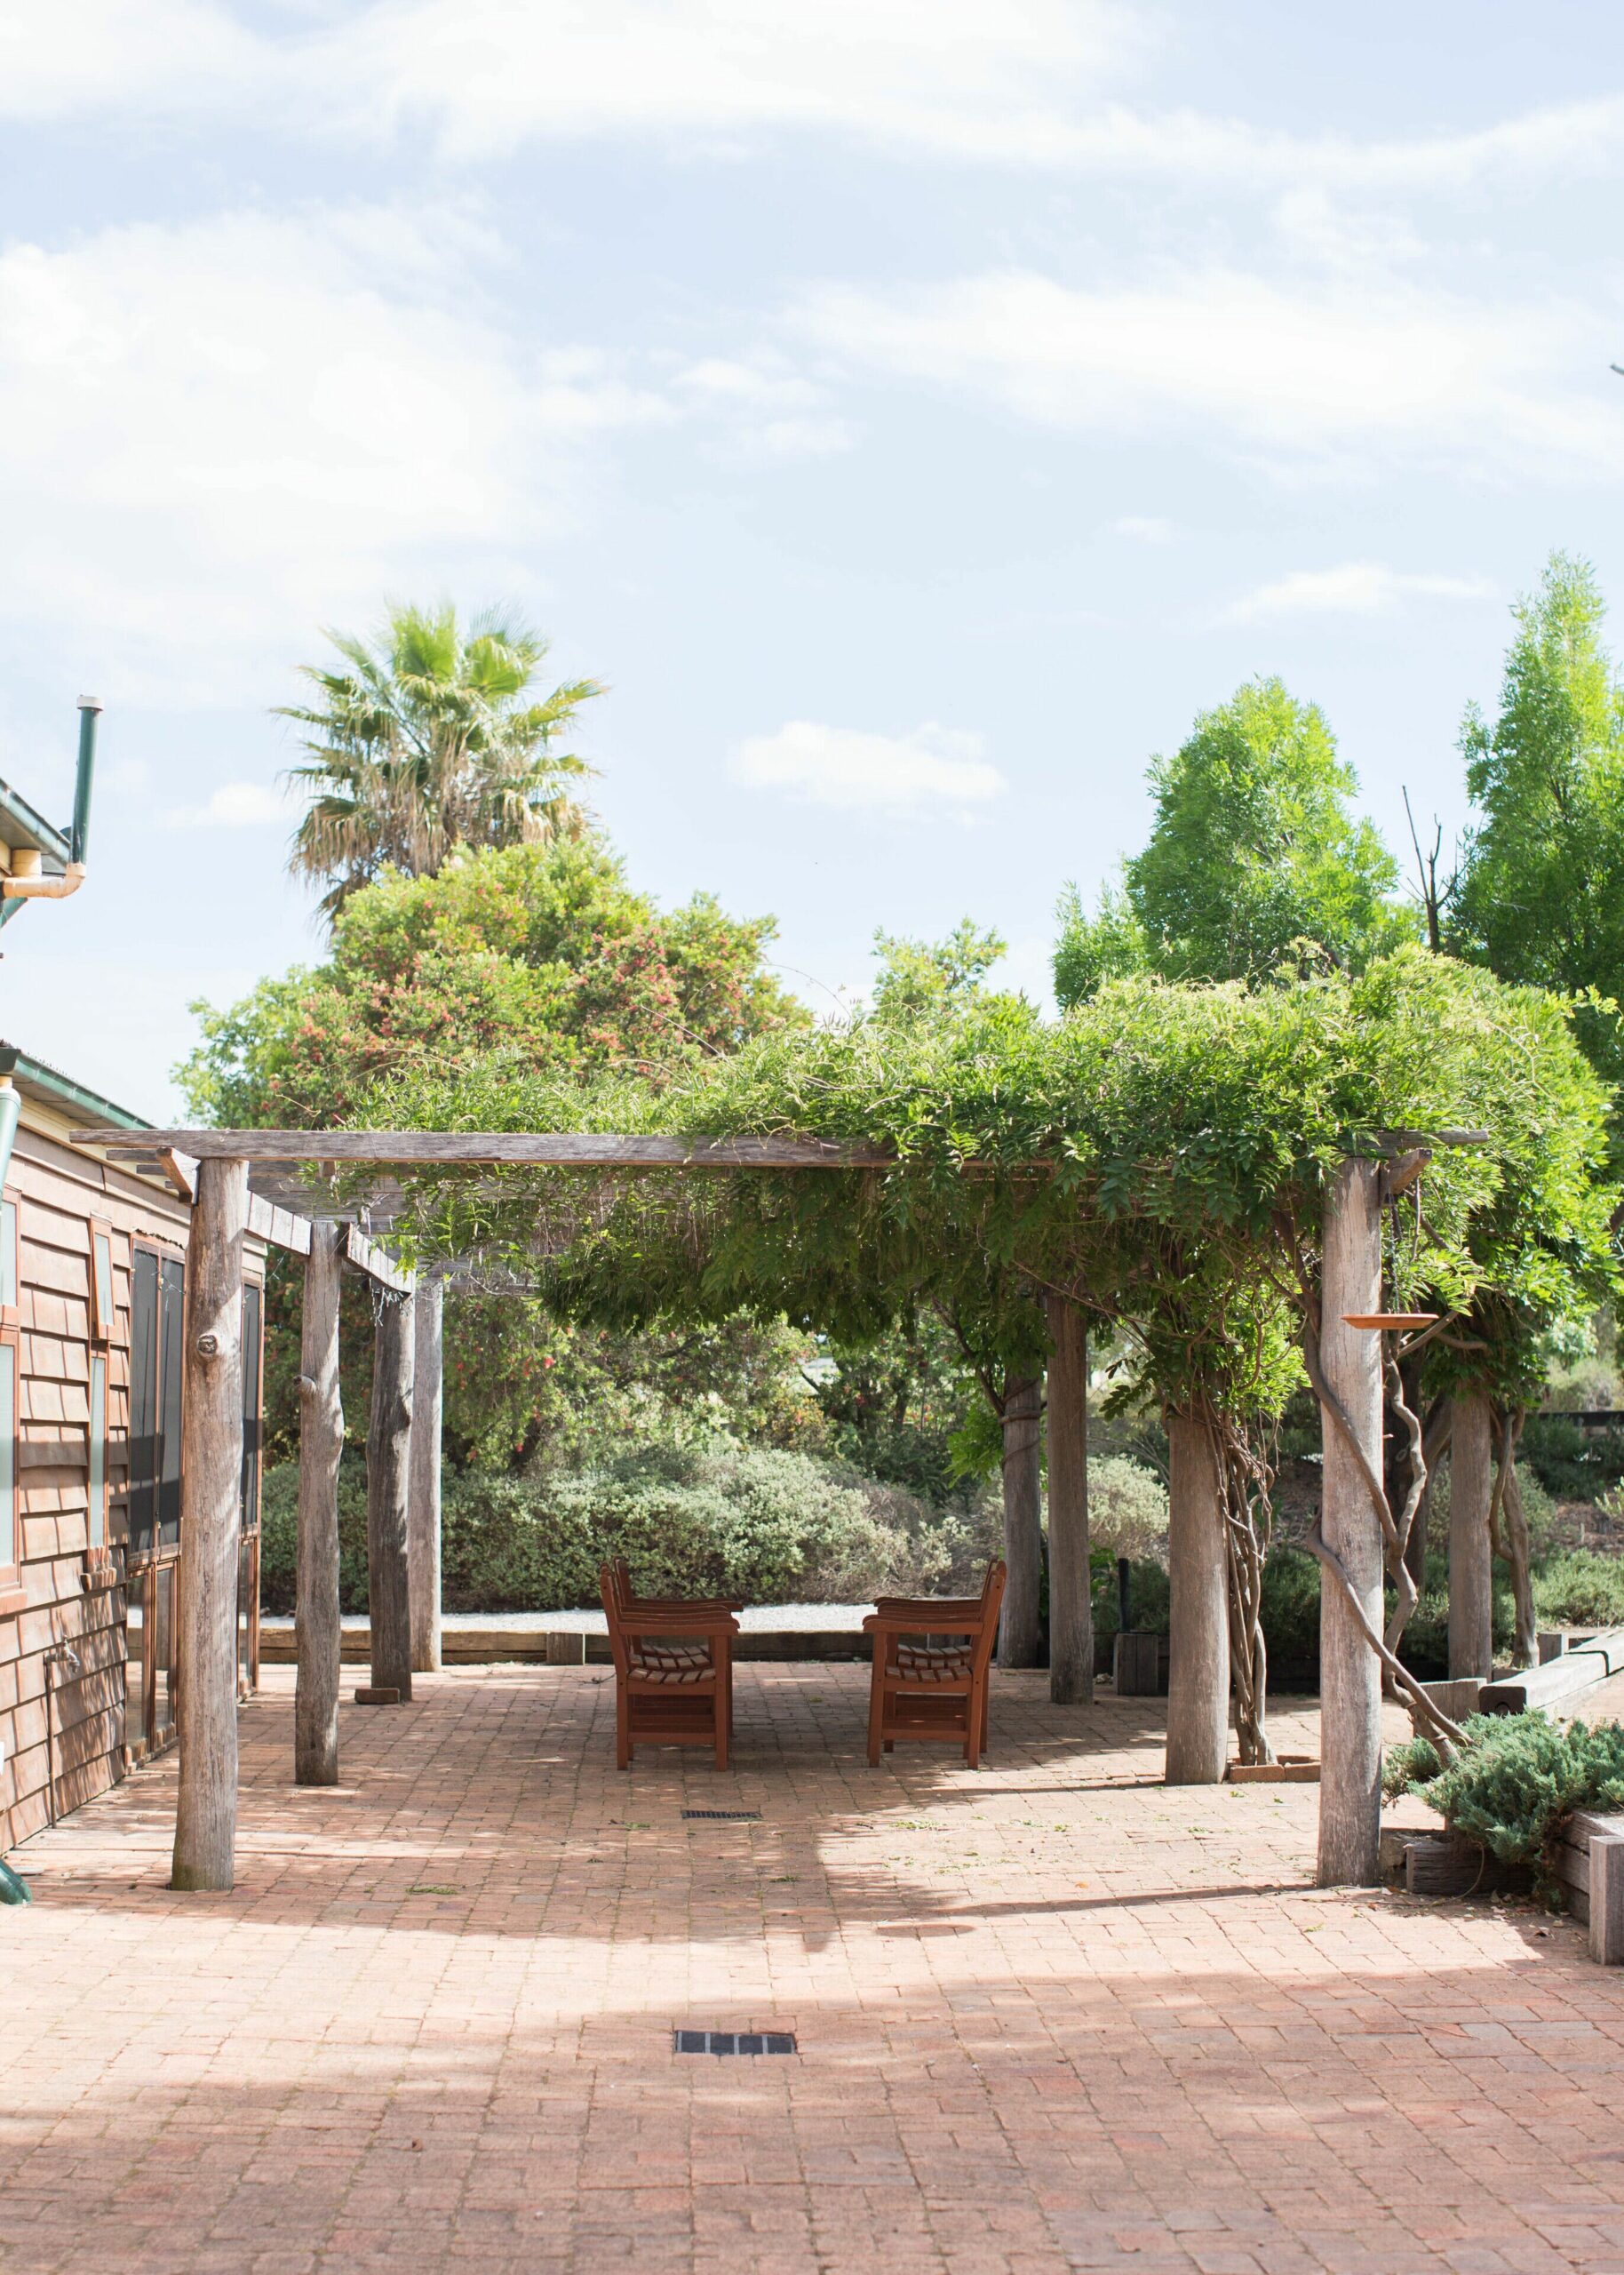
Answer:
[1114,680,1414,980]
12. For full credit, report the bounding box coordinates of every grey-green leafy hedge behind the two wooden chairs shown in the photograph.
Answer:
[261,1442,994,1613]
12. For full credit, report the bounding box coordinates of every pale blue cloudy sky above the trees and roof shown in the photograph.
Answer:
[0,0,1624,1120]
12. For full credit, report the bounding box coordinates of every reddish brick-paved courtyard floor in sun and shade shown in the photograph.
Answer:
[0,1665,1624,2275]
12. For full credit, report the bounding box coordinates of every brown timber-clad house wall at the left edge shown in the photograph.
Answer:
[0,1098,262,1852]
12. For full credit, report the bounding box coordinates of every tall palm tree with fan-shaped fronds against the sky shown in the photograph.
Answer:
[280,603,602,917]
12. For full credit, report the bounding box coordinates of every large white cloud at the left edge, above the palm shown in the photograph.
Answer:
[0,210,671,706]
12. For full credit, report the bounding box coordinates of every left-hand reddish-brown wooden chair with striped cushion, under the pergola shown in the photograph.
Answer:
[598,1556,739,1770]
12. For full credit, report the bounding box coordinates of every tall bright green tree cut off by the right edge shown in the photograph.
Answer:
[1456,553,1624,1081]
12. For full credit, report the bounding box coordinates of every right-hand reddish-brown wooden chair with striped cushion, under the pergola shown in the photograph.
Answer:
[862,1559,1006,1770]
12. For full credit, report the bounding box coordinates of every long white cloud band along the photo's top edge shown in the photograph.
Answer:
[0,0,1624,196]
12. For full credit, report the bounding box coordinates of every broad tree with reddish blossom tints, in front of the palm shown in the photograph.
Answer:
[175,835,809,1463]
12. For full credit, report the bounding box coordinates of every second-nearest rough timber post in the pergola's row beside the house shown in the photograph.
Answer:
[293,1224,344,1786]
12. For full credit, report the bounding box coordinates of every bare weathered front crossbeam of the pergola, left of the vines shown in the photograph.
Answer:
[73,1129,896,1169]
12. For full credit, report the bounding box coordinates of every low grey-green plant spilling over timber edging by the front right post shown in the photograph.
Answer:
[1383,1713,1624,1904]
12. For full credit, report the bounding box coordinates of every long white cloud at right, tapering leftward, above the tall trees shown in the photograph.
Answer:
[787,268,1624,480]
